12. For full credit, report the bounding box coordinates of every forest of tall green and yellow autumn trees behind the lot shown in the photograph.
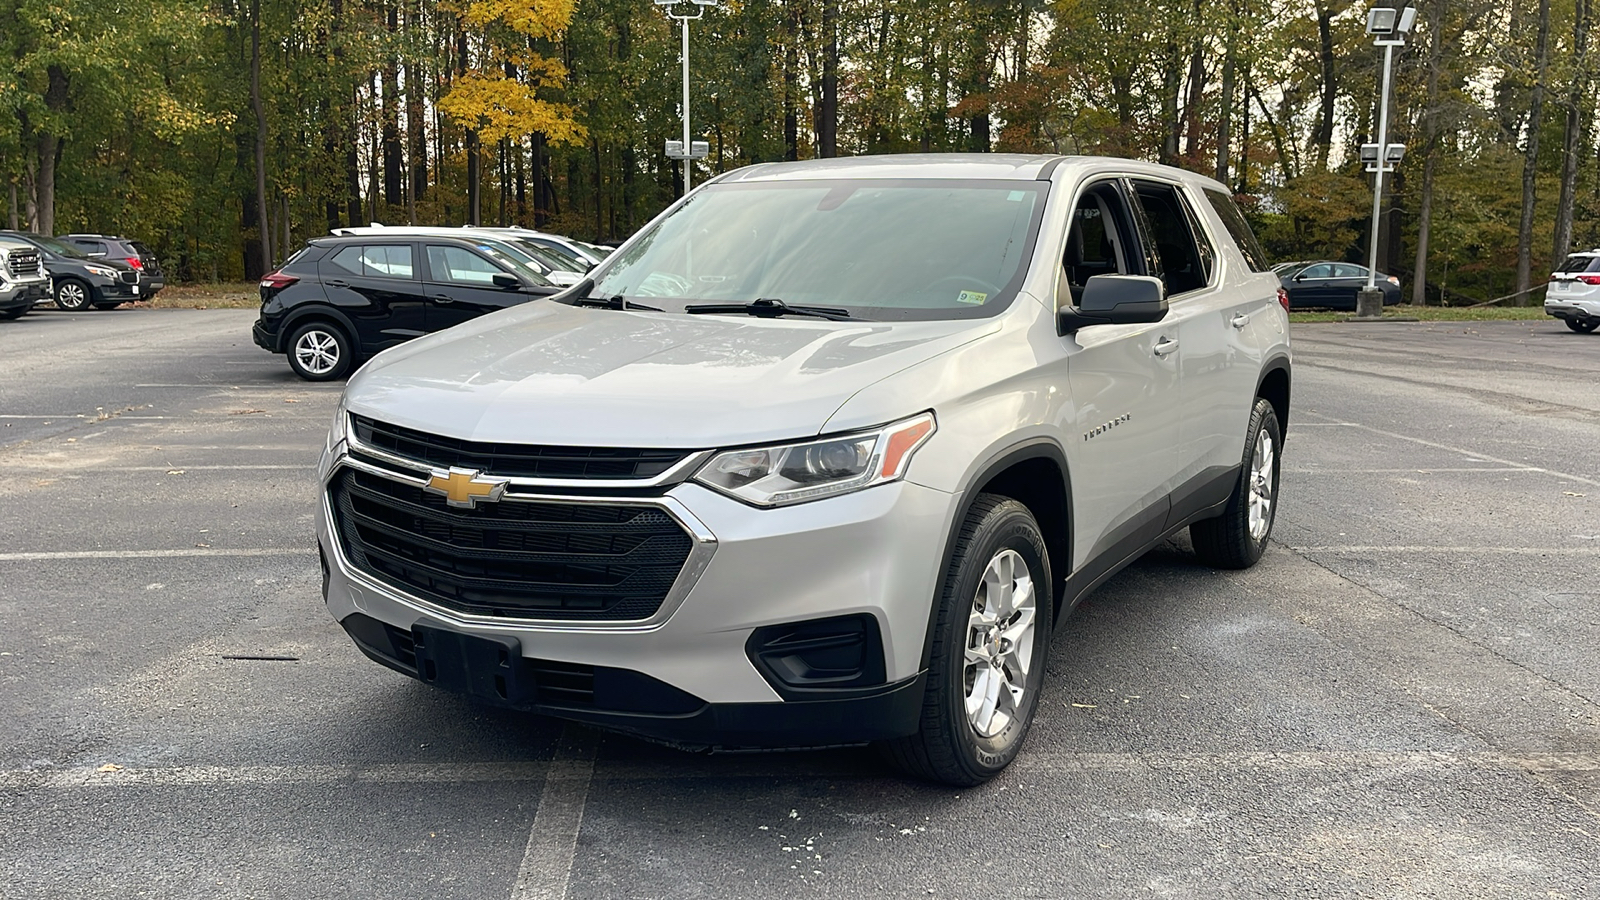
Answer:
[0,0,1600,303]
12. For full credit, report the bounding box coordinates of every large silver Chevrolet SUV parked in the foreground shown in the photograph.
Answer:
[318,155,1290,785]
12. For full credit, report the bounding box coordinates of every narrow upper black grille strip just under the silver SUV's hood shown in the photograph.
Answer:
[350,416,688,480]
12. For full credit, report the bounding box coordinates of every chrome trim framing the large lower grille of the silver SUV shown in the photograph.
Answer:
[322,450,717,634]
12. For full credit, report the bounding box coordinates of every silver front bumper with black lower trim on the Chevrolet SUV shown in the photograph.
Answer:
[318,445,957,748]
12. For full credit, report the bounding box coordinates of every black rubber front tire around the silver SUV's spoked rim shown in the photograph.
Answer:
[882,493,1054,786]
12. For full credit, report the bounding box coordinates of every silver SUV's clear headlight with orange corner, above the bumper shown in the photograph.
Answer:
[694,413,934,506]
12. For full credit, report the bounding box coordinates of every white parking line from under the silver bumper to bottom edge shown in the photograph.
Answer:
[510,725,597,900]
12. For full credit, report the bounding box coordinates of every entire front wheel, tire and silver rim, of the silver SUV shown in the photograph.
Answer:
[883,493,1054,786]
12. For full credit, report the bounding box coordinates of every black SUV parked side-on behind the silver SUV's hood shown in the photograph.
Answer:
[251,234,560,381]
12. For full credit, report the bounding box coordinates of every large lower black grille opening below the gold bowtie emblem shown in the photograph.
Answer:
[328,469,694,621]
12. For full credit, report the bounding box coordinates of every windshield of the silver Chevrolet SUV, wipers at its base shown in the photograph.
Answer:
[594,179,1048,319]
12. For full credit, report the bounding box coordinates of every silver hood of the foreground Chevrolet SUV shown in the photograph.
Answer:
[346,301,998,448]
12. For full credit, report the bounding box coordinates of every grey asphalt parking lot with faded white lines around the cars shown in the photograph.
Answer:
[0,309,1600,898]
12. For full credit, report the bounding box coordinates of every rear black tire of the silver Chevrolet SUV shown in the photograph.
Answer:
[1189,397,1283,569]
